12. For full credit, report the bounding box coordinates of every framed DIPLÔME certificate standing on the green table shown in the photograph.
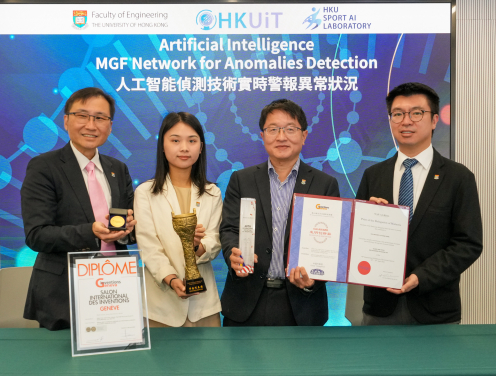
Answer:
[67,251,150,356]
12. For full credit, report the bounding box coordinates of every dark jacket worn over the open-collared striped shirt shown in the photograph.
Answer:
[219,162,339,325]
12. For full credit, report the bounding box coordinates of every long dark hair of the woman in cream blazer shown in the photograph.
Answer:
[151,112,211,197]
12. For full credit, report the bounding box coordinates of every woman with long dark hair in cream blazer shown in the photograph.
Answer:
[134,112,222,327]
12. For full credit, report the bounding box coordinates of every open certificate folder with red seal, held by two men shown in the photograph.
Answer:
[287,193,410,288]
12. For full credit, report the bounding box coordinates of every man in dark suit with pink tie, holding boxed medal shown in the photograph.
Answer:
[21,88,136,330]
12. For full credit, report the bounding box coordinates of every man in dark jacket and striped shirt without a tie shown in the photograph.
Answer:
[220,99,339,326]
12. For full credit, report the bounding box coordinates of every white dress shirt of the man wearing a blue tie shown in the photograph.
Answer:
[393,144,434,212]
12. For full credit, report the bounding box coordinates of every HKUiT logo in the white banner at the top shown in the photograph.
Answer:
[196,9,283,30]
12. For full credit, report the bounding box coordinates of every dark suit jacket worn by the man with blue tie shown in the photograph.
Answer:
[356,150,482,324]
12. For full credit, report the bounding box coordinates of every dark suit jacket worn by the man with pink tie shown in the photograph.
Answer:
[21,144,134,330]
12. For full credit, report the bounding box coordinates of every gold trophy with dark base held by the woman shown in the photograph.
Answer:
[172,208,207,294]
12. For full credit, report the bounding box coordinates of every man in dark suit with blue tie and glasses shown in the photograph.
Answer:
[356,83,482,325]
